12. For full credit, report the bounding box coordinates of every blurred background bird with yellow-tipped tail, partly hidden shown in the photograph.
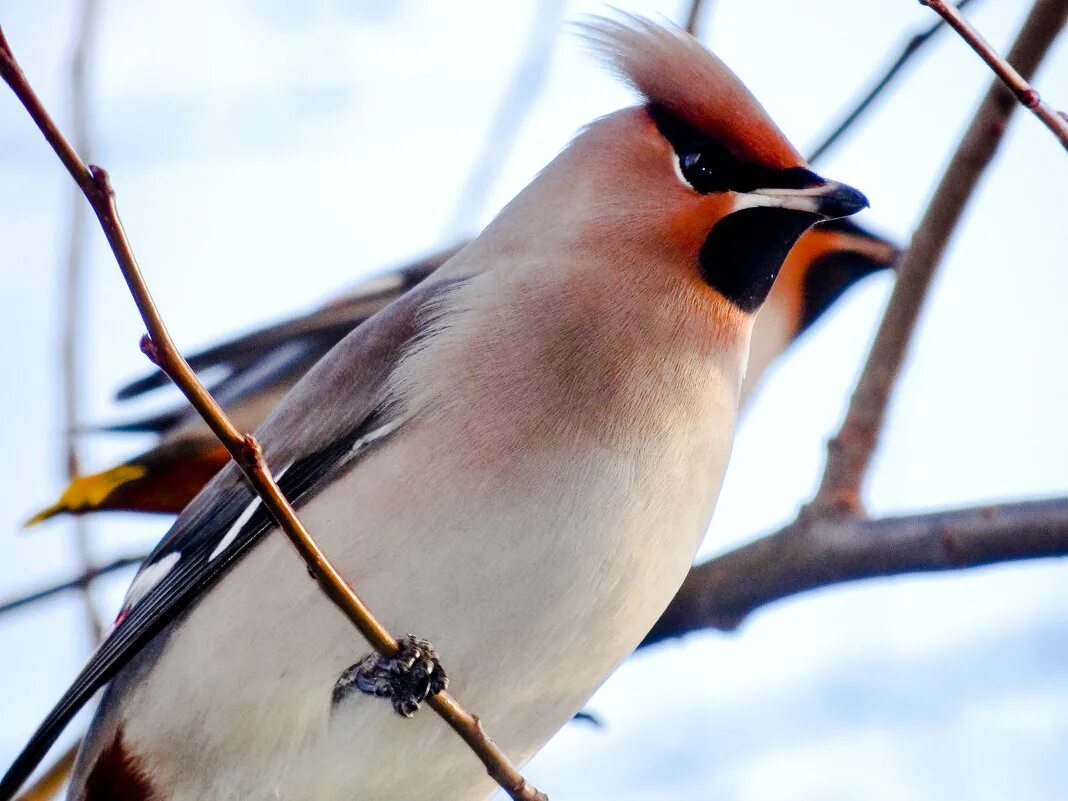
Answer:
[27,219,899,525]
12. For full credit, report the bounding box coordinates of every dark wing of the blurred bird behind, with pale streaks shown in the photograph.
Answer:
[112,248,458,414]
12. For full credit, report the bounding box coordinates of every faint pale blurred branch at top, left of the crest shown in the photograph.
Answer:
[445,0,566,239]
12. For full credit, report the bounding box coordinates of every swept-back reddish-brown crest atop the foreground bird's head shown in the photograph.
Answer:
[578,13,805,170]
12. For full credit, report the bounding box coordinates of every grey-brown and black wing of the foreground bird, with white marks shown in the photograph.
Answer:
[0,281,467,801]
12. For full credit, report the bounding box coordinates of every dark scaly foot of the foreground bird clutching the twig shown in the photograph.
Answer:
[331,634,449,718]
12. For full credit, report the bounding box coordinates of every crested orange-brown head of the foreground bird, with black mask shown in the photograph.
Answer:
[499,16,867,316]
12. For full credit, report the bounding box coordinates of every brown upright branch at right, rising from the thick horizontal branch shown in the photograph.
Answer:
[810,0,1068,514]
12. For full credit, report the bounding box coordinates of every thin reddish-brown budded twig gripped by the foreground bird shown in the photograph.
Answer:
[0,29,545,801]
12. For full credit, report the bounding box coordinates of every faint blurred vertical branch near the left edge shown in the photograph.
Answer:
[60,0,104,643]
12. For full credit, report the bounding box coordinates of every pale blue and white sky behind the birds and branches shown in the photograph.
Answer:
[0,0,1068,801]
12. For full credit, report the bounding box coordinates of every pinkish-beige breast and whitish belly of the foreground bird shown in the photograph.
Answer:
[81,240,748,801]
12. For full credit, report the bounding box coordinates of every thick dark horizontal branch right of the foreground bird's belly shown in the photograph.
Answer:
[642,498,1068,645]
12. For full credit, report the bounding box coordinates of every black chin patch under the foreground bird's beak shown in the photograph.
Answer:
[700,206,822,314]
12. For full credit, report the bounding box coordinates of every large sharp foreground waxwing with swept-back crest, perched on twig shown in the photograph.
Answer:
[0,14,868,801]
